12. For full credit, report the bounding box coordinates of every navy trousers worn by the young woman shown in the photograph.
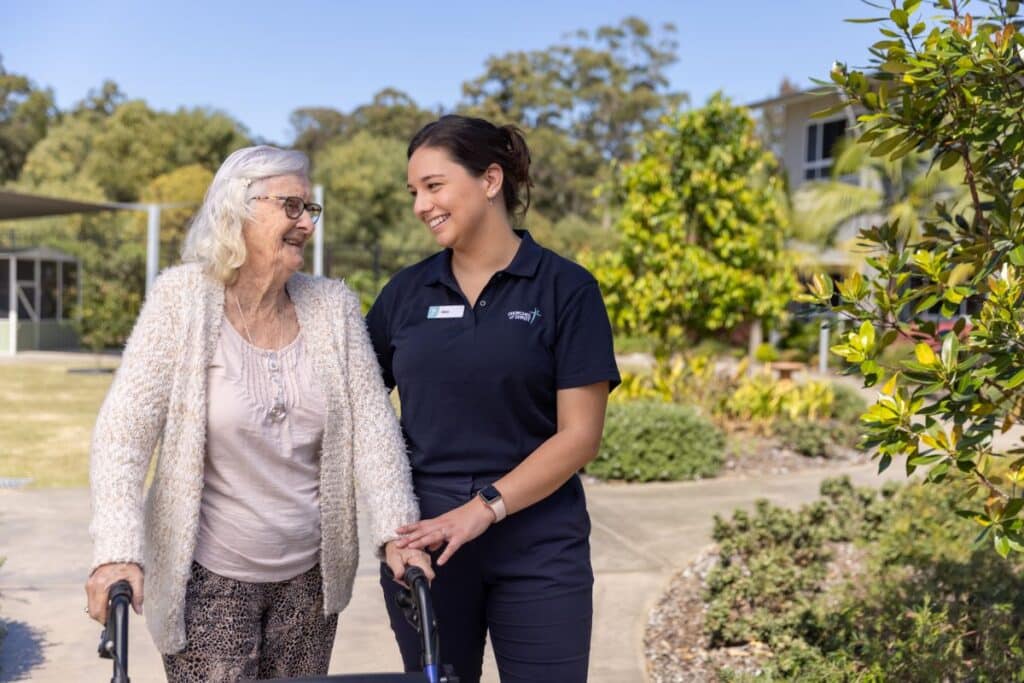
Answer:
[381,475,594,683]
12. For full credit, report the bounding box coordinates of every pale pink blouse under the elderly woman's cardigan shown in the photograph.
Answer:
[195,317,327,583]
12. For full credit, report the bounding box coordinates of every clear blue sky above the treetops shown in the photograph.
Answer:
[0,0,877,143]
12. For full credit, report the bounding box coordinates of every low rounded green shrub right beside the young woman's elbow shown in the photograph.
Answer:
[587,401,725,481]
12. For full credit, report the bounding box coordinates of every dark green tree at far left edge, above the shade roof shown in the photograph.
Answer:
[0,59,57,185]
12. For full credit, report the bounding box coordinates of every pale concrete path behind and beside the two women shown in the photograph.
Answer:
[0,465,899,683]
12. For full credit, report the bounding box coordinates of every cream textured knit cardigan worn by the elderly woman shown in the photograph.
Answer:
[89,263,419,653]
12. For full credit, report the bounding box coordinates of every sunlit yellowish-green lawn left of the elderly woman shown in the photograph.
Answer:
[0,356,114,487]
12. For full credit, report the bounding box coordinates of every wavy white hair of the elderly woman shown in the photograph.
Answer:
[181,144,309,285]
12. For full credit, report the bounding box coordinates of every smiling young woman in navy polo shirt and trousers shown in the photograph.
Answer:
[368,116,618,683]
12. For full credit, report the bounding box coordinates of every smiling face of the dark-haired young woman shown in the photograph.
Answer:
[408,146,502,248]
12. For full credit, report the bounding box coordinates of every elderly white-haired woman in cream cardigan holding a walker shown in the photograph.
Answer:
[86,146,433,682]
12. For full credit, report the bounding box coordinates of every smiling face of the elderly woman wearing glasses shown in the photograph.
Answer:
[242,175,314,278]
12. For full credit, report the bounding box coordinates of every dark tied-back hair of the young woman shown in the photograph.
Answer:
[407,114,531,218]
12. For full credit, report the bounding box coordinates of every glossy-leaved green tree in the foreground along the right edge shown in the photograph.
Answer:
[809,0,1024,555]
